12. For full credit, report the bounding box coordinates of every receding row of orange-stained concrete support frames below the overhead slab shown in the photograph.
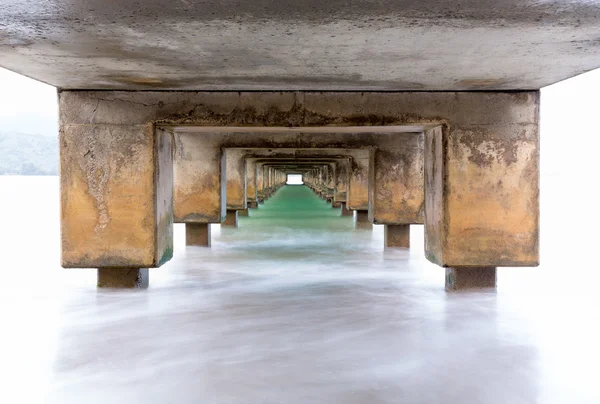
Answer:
[59,91,539,290]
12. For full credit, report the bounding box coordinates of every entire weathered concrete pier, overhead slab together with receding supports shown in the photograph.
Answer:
[0,0,576,290]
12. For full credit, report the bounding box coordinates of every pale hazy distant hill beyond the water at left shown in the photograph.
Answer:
[0,132,58,175]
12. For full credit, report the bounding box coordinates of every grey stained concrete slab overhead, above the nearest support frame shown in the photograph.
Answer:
[0,0,600,91]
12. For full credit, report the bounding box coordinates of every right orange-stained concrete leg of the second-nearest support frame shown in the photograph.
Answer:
[369,133,425,224]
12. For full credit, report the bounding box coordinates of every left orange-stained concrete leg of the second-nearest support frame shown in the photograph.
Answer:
[173,133,227,223]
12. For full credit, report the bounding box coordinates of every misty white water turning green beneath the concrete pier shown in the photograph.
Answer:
[0,177,600,404]
